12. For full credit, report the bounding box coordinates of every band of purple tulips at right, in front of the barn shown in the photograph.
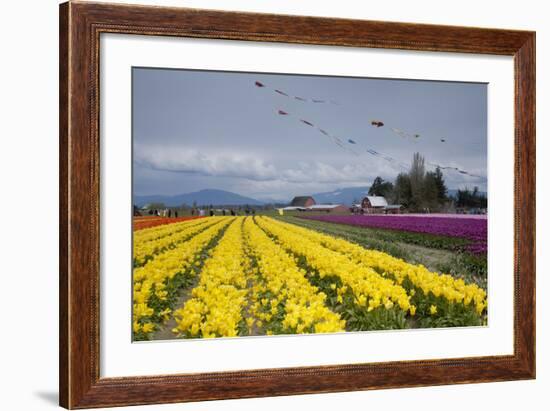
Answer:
[305,215,487,254]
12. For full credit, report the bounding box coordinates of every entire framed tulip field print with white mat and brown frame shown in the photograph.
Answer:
[60,2,535,408]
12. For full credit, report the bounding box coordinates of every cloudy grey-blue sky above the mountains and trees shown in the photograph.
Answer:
[132,68,487,201]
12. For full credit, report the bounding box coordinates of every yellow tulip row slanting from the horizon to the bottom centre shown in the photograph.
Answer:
[244,218,345,334]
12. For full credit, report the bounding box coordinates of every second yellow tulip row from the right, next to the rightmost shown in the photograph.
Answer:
[257,217,415,314]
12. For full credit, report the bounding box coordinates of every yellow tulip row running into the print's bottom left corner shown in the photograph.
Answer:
[133,217,237,334]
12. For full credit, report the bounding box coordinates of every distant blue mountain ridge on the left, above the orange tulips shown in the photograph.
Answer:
[134,189,264,207]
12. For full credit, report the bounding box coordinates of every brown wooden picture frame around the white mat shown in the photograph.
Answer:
[59,2,535,409]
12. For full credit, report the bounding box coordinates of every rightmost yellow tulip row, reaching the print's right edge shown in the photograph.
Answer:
[262,219,487,314]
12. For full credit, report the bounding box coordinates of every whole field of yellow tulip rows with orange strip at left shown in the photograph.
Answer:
[132,216,487,341]
